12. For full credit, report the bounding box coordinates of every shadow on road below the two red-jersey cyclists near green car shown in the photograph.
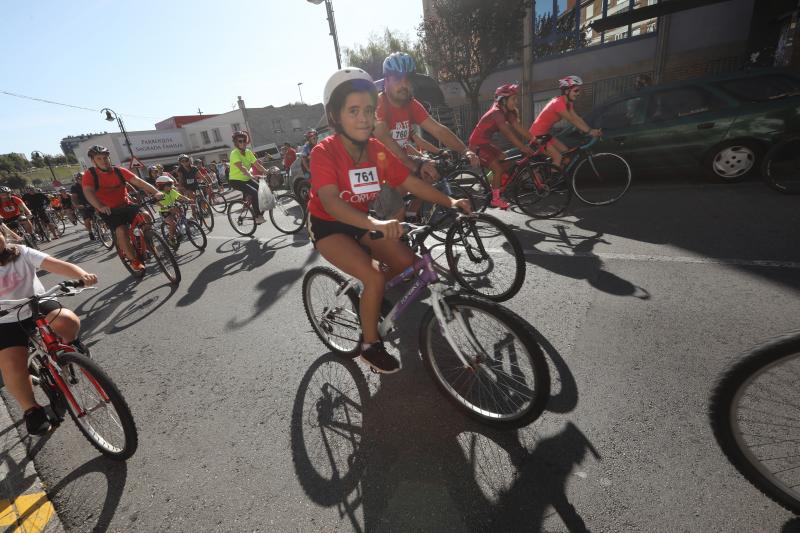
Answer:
[520,220,650,300]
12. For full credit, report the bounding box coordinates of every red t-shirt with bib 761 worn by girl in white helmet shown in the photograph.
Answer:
[308,135,409,220]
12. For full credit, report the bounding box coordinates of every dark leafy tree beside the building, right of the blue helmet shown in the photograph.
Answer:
[418,0,527,116]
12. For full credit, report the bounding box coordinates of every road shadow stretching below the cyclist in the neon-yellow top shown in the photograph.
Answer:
[177,239,275,307]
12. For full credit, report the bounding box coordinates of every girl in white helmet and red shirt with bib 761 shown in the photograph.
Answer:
[308,68,470,374]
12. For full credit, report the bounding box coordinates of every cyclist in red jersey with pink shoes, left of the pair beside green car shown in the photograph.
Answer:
[469,84,536,209]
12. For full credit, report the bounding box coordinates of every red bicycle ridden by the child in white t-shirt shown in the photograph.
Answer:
[0,280,139,461]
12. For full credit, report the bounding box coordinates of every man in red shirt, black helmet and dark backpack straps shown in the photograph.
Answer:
[81,145,164,270]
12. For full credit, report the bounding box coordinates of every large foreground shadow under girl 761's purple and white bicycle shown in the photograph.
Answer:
[290,296,599,532]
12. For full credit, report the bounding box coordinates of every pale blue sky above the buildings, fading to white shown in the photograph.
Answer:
[0,0,422,156]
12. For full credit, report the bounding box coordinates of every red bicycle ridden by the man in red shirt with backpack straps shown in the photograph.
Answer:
[111,199,181,285]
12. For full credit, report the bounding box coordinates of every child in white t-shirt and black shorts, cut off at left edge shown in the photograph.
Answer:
[0,231,97,435]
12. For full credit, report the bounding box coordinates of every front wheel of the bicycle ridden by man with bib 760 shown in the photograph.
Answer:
[445,213,525,302]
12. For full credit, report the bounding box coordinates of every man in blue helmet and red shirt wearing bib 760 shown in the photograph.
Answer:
[373,52,478,220]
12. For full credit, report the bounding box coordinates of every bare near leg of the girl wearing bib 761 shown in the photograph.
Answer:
[315,233,386,344]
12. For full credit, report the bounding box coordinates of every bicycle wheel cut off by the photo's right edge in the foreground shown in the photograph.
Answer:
[709,333,800,513]
